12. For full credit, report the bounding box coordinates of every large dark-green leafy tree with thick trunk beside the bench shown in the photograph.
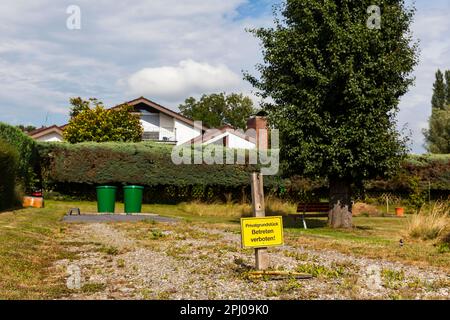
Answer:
[246,0,417,227]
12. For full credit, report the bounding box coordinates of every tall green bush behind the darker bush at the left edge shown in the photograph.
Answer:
[0,122,38,189]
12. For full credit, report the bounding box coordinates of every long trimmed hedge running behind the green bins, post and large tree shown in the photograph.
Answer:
[39,142,450,203]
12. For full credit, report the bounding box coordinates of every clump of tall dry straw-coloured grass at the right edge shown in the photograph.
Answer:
[407,202,450,240]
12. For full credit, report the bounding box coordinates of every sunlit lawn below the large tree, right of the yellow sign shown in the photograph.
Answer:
[285,215,450,271]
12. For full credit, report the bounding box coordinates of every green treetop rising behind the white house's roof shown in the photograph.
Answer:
[179,93,255,129]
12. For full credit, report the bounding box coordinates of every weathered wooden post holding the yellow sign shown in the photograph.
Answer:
[251,172,269,270]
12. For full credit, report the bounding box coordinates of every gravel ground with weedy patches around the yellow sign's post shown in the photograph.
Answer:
[55,222,450,299]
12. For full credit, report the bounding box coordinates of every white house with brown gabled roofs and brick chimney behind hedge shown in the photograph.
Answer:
[29,97,267,149]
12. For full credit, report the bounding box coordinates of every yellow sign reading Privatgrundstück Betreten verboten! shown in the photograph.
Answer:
[241,217,284,248]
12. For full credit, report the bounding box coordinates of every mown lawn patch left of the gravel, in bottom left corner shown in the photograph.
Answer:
[0,203,68,299]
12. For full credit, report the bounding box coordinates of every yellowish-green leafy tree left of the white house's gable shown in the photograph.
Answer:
[64,98,143,143]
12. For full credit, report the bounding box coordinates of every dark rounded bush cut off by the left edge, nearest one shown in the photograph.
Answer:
[0,140,19,210]
